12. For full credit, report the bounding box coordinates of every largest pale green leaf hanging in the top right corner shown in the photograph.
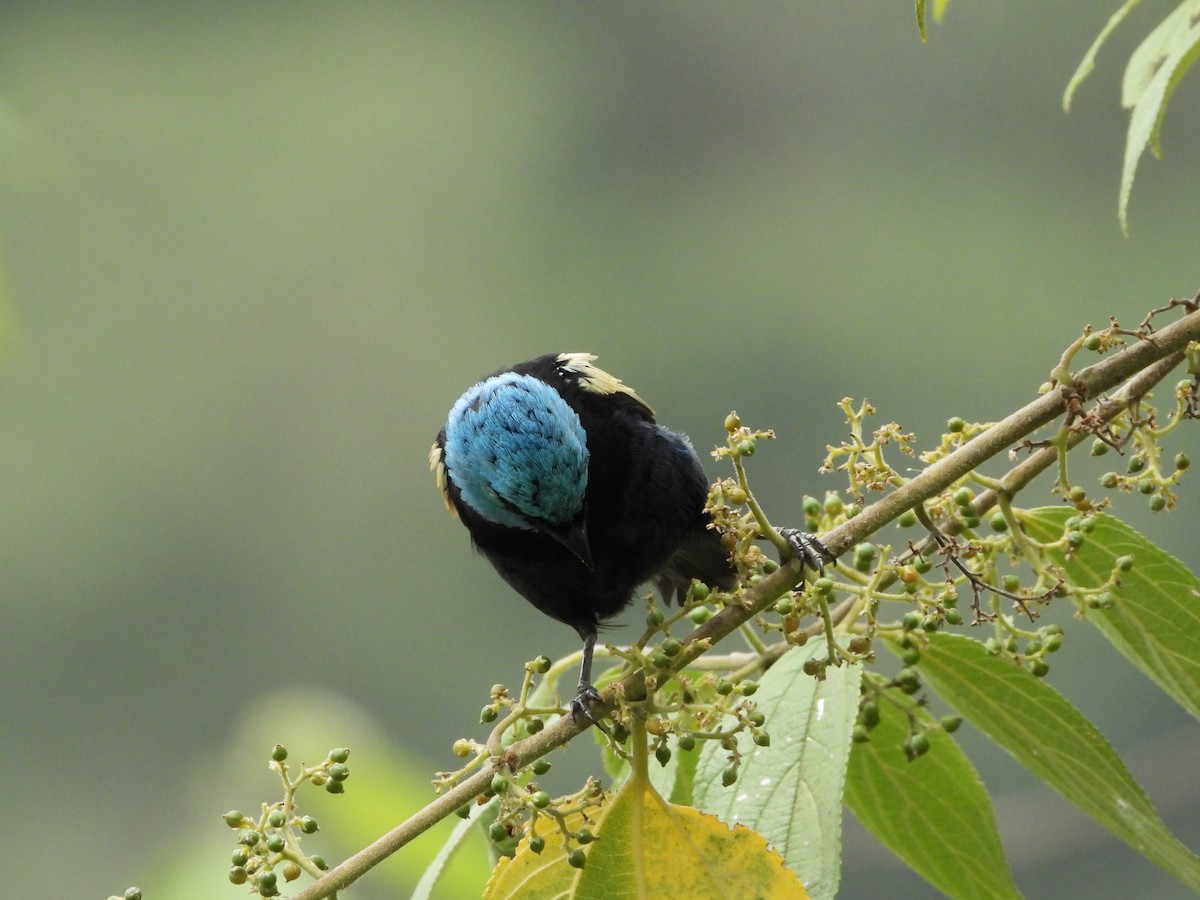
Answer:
[1117,0,1200,233]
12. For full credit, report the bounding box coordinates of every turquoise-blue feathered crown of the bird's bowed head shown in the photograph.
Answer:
[443,372,588,530]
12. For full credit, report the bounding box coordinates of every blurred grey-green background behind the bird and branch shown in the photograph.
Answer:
[0,0,1200,899]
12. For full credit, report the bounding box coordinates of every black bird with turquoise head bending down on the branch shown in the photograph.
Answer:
[430,353,736,710]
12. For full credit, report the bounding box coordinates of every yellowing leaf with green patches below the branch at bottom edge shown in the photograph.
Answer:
[484,775,808,900]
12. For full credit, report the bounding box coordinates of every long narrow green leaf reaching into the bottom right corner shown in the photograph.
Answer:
[920,634,1200,890]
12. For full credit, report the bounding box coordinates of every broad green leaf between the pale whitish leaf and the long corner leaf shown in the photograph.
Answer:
[846,672,1021,900]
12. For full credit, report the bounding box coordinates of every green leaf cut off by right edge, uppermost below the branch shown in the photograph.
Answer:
[1021,506,1200,719]
